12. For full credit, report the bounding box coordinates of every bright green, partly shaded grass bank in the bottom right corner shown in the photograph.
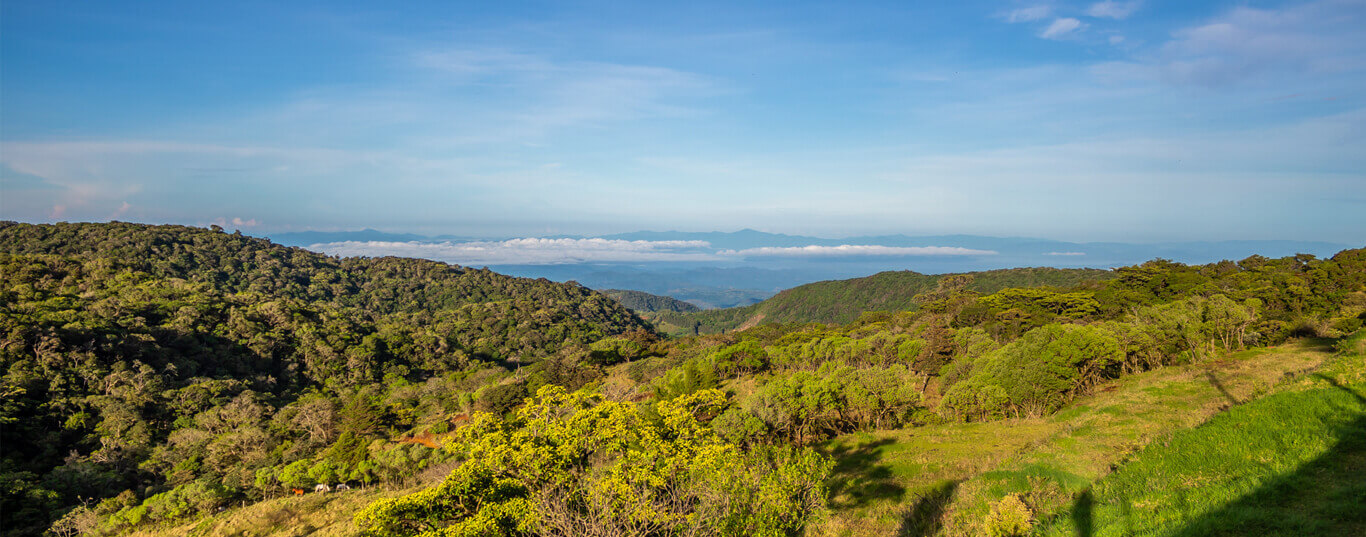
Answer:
[1041,334,1366,537]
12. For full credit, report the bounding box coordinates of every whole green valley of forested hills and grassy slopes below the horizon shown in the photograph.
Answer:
[0,223,1366,536]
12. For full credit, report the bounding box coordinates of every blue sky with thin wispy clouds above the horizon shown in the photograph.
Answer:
[0,0,1366,243]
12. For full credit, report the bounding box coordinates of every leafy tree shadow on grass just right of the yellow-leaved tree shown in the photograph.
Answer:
[826,439,906,508]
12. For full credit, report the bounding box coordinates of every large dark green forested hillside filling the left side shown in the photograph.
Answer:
[0,223,653,534]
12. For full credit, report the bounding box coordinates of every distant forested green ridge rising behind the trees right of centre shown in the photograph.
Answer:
[646,268,1113,335]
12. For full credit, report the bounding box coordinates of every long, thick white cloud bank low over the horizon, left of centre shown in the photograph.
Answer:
[309,238,717,266]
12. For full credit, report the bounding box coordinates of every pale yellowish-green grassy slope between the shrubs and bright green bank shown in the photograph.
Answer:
[817,338,1332,536]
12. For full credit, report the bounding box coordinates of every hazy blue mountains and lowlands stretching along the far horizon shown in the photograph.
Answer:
[266,230,1362,307]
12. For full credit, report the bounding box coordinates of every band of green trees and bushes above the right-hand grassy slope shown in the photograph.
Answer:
[653,251,1366,434]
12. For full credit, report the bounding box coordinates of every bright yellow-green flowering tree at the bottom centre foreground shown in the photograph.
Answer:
[357,385,831,537]
